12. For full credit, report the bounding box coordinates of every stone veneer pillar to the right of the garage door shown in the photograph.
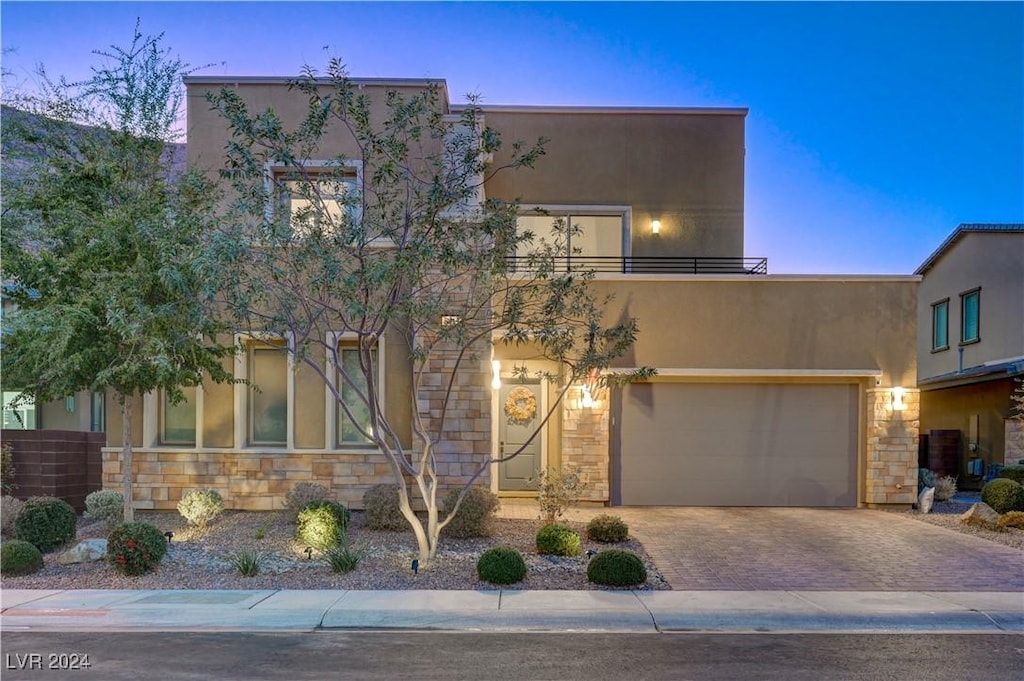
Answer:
[864,388,921,506]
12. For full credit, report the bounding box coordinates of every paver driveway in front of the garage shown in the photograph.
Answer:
[502,502,1024,591]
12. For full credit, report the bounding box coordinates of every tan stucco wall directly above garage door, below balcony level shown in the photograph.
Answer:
[594,276,918,387]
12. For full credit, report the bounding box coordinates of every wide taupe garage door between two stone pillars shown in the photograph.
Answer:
[612,383,858,506]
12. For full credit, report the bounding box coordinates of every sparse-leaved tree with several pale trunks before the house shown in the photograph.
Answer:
[201,59,643,564]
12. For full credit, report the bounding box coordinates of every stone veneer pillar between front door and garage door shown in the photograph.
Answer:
[562,386,610,502]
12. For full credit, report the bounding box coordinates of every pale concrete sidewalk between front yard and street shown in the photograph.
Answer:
[0,589,1024,633]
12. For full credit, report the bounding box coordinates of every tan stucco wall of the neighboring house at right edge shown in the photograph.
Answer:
[918,231,1024,382]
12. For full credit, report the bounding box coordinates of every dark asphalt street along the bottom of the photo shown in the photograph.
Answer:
[2,631,1024,681]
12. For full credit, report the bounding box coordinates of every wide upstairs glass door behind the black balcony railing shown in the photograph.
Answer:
[517,211,627,269]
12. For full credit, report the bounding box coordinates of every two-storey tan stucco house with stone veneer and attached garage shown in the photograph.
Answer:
[103,77,920,509]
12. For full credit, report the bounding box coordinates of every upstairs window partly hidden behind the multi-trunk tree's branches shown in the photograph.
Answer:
[268,161,361,237]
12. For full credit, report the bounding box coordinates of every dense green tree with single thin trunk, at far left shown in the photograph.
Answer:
[2,26,232,521]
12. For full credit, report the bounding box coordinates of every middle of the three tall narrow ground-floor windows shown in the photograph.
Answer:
[247,341,289,446]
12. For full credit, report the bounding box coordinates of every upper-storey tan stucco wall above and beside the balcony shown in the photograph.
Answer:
[484,108,757,257]
